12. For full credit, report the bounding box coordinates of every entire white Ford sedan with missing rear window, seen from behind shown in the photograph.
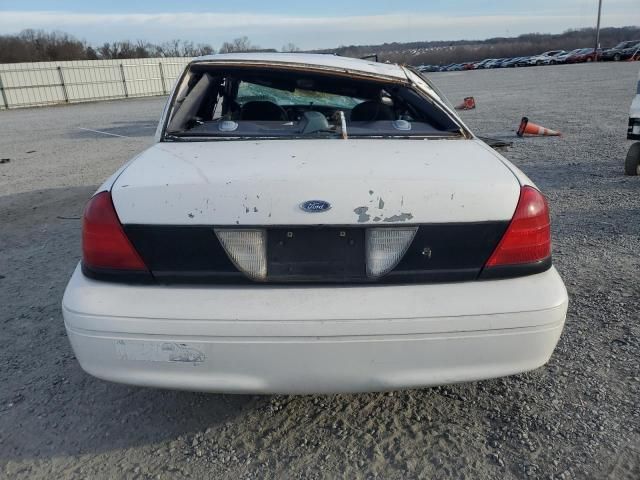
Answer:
[62,53,567,393]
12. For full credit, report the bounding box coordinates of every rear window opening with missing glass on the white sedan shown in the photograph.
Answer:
[165,64,461,139]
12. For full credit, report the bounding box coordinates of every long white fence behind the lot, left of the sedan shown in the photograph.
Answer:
[0,57,191,110]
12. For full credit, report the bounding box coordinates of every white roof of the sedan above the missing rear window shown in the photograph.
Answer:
[193,52,407,80]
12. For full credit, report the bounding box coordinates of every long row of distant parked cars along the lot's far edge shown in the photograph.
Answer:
[418,40,640,72]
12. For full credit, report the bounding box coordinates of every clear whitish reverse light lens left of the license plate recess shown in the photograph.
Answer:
[215,229,267,280]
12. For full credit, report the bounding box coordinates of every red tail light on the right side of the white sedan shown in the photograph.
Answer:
[485,187,551,267]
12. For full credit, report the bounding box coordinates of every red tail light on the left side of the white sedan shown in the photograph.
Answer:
[82,192,147,272]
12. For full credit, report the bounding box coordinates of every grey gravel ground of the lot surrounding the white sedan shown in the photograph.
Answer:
[0,63,640,480]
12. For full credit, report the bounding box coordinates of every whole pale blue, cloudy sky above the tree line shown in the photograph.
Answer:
[0,0,640,49]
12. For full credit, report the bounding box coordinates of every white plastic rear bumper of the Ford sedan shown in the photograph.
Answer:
[62,268,567,393]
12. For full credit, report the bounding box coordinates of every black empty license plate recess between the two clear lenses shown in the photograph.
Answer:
[267,227,366,282]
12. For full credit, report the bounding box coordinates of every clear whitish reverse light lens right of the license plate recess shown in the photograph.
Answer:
[366,227,418,277]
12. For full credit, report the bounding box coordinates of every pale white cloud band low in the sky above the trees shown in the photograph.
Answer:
[0,10,640,48]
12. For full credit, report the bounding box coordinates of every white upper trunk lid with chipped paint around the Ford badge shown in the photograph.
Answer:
[112,139,520,225]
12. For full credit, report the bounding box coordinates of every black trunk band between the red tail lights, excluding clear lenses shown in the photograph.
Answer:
[124,221,509,284]
